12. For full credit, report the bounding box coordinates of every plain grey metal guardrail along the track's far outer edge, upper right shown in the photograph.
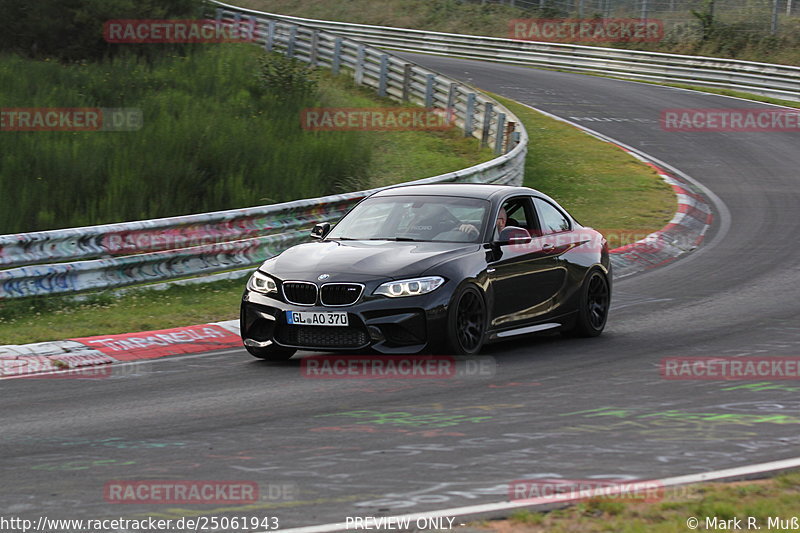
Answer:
[215,2,800,101]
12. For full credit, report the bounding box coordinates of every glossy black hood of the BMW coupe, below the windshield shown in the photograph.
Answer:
[262,241,480,282]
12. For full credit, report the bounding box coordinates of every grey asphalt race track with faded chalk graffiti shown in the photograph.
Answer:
[0,55,800,528]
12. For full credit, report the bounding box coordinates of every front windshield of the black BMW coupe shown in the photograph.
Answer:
[328,196,489,242]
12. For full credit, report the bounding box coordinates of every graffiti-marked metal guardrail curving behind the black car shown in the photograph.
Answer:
[0,11,528,300]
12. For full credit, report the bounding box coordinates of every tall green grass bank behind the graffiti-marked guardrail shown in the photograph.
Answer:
[0,44,492,234]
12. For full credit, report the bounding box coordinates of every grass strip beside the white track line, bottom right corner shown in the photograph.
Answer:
[470,471,800,533]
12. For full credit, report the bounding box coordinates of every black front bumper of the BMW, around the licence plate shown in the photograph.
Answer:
[240,288,448,354]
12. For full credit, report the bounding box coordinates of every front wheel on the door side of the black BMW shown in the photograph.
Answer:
[447,285,487,355]
